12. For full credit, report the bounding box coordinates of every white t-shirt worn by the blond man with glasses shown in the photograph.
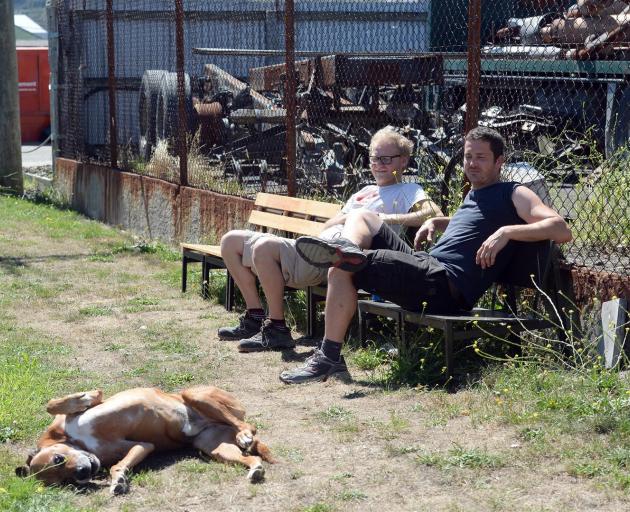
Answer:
[319,183,427,238]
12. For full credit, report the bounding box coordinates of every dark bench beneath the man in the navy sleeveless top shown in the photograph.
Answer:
[358,241,561,381]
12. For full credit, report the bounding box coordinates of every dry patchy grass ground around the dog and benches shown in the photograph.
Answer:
[0,196,630,511]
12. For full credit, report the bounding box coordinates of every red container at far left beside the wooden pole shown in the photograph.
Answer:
[17,46,50,143]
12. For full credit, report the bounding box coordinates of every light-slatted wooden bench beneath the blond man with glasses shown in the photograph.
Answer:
[180,192,341,336]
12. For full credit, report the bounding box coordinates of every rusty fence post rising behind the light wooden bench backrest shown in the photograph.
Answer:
[284,0,297,196]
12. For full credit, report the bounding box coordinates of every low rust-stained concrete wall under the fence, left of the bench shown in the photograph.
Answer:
[54,158,254,243]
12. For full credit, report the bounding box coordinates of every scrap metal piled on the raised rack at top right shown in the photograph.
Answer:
[494,0,630,60]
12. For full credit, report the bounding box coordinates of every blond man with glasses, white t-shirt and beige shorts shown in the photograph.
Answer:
[218,128,441,352]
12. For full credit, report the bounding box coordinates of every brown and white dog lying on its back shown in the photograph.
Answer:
[15,386,274,494]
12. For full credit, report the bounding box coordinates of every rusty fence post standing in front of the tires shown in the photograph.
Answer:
[175,0,188,186]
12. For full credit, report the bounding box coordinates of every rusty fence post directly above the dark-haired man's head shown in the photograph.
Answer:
[464,0,481,133]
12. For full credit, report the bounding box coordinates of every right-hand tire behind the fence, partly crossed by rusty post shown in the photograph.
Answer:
[155,73,193,150]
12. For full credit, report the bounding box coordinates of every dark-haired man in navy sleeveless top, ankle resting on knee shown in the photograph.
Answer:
[280,127,572,384]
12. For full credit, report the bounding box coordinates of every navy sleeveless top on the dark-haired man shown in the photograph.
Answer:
[429,182,525,306]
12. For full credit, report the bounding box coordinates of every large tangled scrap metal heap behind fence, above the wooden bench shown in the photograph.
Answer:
[140,55,455,193]
